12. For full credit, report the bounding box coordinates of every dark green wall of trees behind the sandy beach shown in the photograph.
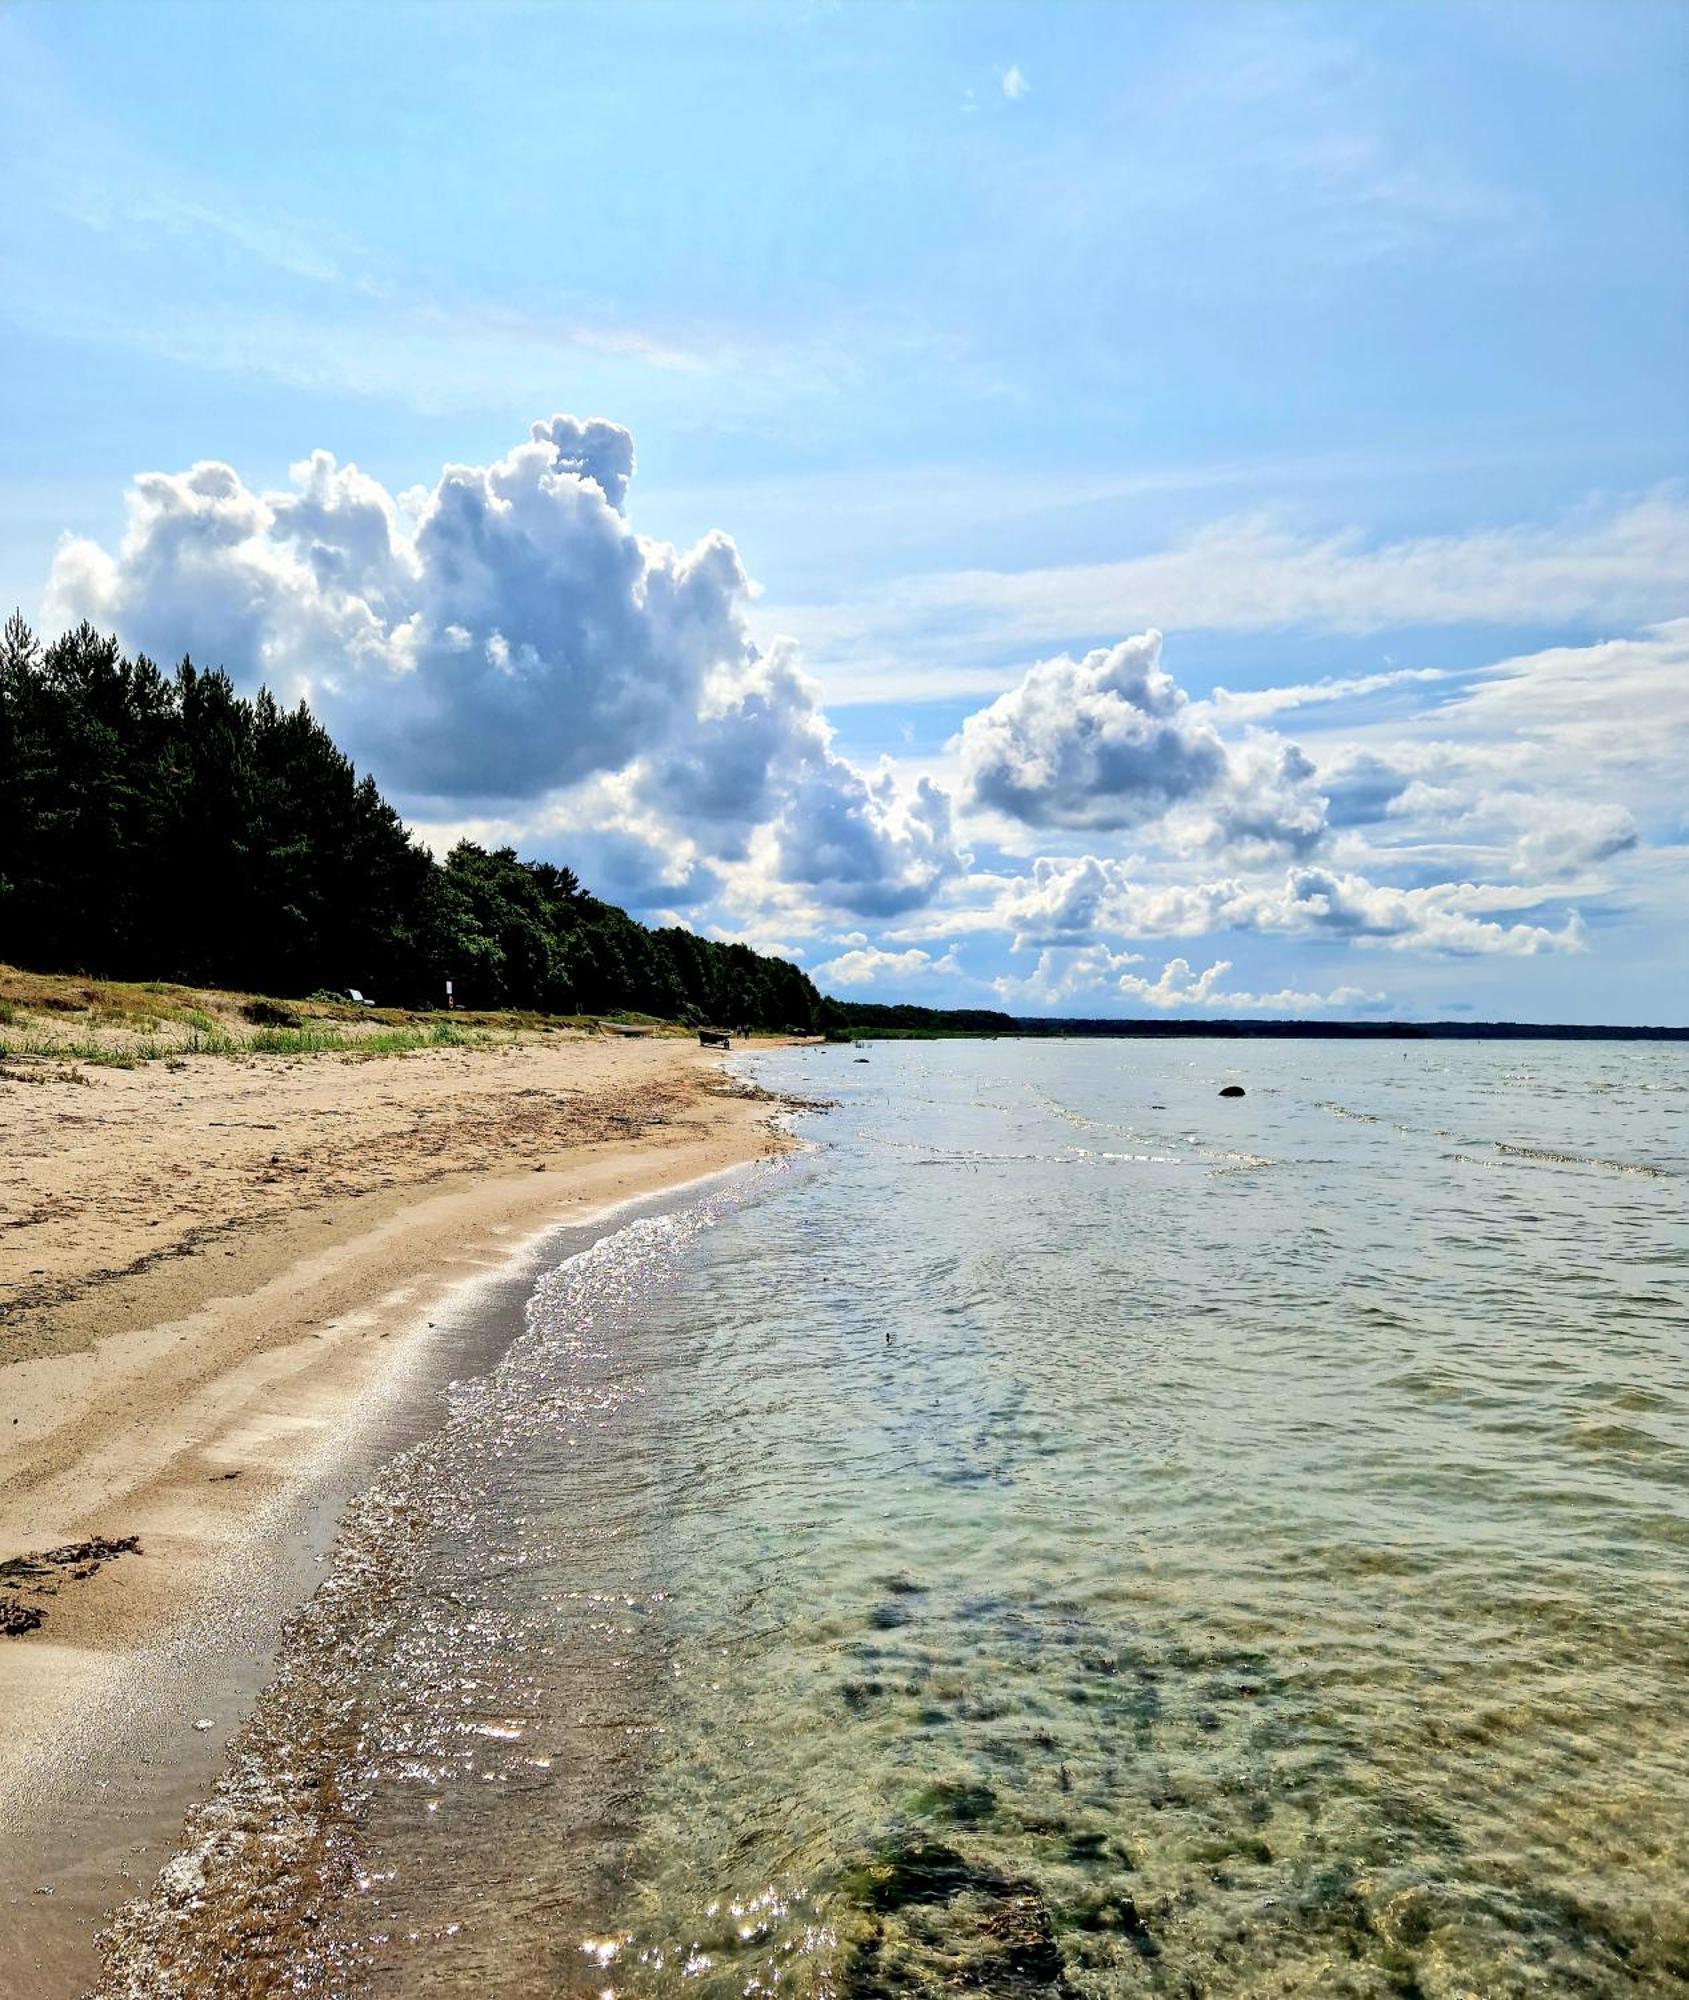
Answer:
[0,616,820,1028]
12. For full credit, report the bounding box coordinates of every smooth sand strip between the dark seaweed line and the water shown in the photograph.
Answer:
[0,1042,804,1996]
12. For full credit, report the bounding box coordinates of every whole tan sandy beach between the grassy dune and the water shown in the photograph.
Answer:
[0,1034,782,1992]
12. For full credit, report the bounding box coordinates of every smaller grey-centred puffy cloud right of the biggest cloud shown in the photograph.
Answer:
[957,632,1325,854]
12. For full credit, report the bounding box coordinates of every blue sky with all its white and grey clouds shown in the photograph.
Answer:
[0,0,1689,1024]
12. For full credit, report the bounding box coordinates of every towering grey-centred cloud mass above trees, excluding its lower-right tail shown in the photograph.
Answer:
[50,416,750,798]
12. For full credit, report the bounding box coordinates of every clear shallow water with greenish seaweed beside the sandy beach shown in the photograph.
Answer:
[102,1042,1689,1996]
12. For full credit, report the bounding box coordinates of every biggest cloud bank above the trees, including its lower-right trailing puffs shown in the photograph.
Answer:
[50,416,961,912]
